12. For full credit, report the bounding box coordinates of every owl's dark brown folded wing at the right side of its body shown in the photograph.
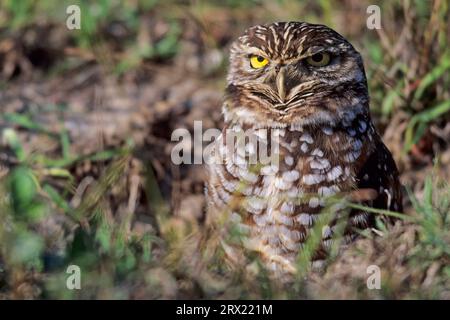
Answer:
[350,138,403,229]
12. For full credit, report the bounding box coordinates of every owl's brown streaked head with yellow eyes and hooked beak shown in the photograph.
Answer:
[224,22,368,127]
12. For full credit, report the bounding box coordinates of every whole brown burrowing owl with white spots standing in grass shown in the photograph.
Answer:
[206,22,402,273]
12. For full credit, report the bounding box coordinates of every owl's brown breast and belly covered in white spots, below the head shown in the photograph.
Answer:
[207,116,376,269]
